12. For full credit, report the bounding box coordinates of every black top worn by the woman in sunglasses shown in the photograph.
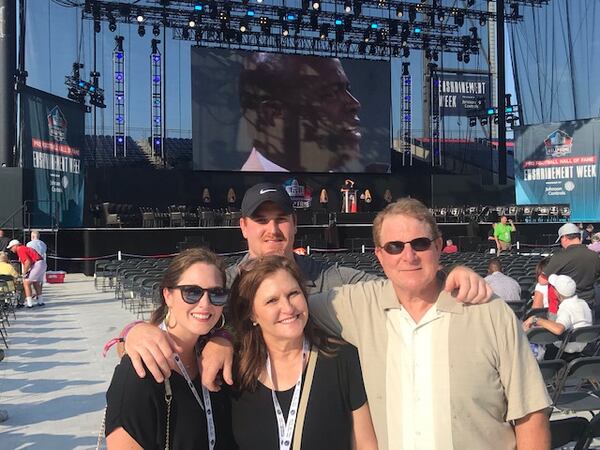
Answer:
[106,356,234,450]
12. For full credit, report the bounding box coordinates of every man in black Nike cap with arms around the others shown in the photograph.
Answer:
[125,183,492,390]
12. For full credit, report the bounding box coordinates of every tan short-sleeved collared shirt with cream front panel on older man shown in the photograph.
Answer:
[310,280,550,450]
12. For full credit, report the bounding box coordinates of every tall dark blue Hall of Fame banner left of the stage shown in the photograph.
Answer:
[21,87,84,228]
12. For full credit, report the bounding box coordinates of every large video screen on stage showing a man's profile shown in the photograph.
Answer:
[191,47,390,172]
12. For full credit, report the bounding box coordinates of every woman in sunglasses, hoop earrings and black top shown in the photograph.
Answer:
[105,249,234,450]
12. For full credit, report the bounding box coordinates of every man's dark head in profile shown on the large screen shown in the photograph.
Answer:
[248,56,362,172]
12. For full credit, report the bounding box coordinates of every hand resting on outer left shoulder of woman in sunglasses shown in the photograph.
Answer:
[125,323,178,383]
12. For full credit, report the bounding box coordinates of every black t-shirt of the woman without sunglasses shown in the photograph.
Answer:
[231,345,367,450]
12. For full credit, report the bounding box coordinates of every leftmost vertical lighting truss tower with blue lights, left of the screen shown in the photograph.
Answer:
[113,36,127,157]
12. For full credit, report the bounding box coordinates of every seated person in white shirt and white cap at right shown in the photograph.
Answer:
[523,274,592,361]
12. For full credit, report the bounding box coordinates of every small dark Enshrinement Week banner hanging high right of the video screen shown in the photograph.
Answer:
[433,72,491,117]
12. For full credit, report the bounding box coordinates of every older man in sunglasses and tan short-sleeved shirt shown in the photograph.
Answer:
[310,199,550,450]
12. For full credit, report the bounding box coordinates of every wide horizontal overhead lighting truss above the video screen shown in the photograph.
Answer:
[83,0,548,59]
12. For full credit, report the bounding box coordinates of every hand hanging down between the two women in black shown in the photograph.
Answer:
[198,337,233,392]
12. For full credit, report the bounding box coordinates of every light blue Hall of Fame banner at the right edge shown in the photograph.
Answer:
[515,119,600,222]
